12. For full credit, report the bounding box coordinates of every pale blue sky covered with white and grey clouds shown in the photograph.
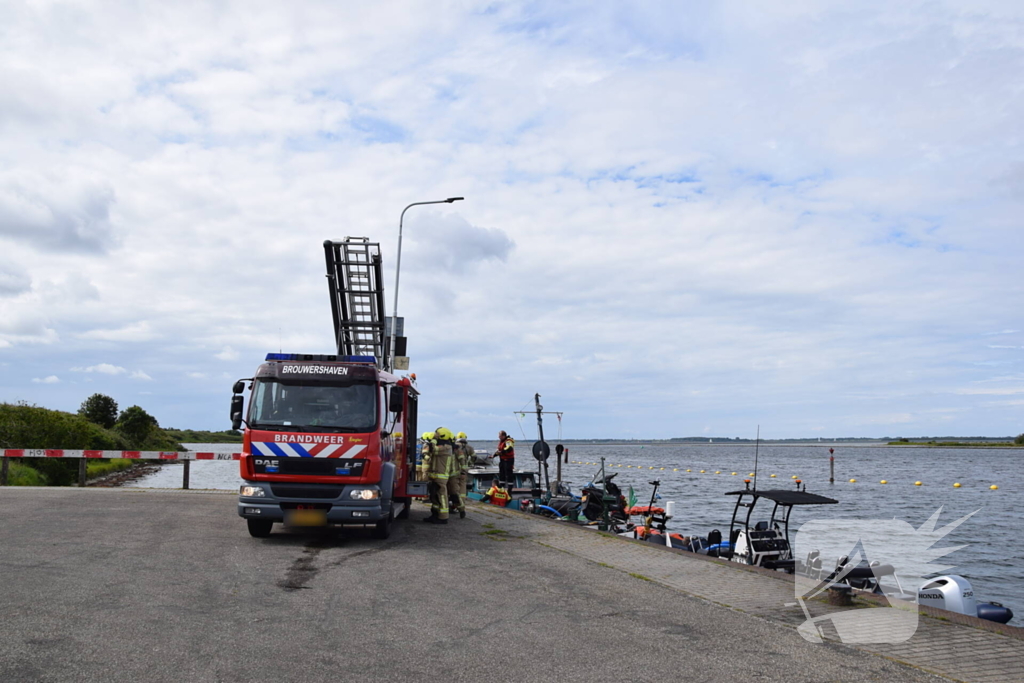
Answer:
[0,0,1024,439]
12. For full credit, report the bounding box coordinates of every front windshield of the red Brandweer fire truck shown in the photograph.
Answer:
[249,379,377,432]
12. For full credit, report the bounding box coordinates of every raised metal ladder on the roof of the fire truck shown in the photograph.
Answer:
[324,238,388,368]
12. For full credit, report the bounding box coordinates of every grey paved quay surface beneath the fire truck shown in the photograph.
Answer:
[0,487,1024,683]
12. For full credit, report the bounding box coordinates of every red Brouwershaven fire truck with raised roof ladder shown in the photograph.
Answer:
[231,238,426,539]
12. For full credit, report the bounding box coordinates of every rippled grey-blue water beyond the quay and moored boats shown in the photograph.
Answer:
[134,440,1024,626]
